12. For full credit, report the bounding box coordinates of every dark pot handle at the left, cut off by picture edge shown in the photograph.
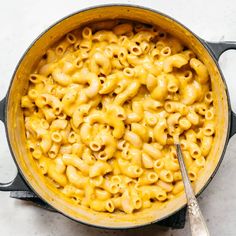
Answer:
[0,97,29,191]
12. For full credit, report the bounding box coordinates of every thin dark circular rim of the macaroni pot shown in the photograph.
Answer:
[4,3,232,230]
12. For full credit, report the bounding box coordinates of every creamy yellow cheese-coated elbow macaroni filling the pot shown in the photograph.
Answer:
[21,21,216,214]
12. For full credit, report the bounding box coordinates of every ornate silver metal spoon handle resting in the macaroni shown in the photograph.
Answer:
[175,144,210,236]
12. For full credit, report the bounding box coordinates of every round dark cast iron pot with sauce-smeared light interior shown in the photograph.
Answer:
[0,5,236,229]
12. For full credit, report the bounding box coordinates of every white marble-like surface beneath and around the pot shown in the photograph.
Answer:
[0,0,236,236]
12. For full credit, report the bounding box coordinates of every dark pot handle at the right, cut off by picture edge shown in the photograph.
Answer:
[205,41,236,137]
